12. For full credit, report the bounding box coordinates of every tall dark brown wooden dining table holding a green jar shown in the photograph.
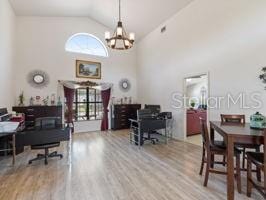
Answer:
[210,121,264,200]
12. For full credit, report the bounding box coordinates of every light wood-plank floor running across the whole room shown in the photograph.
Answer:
[0,131,263,200]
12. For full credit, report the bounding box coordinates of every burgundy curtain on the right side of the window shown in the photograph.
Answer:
[101,88,111,131]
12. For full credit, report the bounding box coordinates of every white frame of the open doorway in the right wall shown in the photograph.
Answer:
[183,71,210,141]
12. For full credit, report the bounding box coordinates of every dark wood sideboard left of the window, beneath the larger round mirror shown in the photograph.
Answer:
[12,106,63,129]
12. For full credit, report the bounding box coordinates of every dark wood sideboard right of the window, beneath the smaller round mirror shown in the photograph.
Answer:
[111,104,141,130]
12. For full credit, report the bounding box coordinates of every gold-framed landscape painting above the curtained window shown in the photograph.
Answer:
[76,60,101,79]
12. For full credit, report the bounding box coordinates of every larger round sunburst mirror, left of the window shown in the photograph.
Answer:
[28,70,49,88]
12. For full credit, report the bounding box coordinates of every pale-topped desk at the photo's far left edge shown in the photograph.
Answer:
[0,122,20,165]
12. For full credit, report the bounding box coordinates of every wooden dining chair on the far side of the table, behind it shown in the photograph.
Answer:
[221,114,261,174]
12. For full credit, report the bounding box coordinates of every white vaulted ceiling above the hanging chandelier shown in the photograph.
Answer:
[9,0,193,38]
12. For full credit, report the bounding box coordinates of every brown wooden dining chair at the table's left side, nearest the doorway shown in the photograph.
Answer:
[199,118,241,193]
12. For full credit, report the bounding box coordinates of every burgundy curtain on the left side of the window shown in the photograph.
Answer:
[64,86,75,131]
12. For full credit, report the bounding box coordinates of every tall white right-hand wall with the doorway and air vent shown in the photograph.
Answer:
[137,0,266,139]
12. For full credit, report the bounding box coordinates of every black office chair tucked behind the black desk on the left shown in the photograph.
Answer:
[29,117,63,165]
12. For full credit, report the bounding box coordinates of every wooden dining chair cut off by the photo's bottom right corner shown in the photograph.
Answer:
[246,129,266,199]
